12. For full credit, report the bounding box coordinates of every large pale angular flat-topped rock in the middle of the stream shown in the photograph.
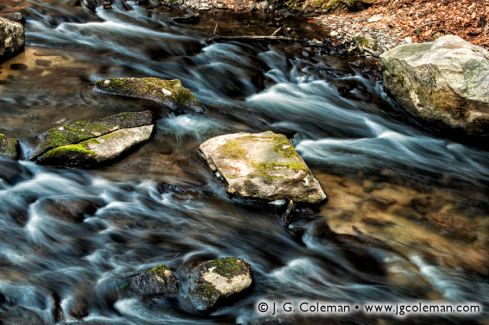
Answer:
[199,131,326,204]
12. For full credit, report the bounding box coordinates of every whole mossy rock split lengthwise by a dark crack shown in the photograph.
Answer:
[32,111,154,167]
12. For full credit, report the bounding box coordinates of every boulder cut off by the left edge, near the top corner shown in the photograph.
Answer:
[0,17,25,62]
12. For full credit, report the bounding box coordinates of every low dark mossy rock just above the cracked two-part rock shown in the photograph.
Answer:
[95,78,202,111]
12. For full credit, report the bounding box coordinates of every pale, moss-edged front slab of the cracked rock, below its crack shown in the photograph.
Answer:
[37,125,154,167]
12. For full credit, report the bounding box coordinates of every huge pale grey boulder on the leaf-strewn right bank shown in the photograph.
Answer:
[380,35,489,135]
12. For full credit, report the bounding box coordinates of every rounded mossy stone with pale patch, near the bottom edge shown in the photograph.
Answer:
[188,257,253,312]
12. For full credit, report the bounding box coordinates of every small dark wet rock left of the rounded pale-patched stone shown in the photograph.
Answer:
[130,264,180,297]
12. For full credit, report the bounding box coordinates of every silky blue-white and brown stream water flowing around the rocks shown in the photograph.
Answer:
[0,0,489,324]
